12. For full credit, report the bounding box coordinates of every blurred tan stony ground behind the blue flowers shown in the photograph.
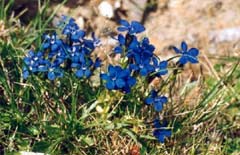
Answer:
[8,0,240,68]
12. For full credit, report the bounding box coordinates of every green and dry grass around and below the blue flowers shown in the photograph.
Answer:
[0,1,240,155]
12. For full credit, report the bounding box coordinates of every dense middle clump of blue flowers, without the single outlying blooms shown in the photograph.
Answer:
[101,20,168,93]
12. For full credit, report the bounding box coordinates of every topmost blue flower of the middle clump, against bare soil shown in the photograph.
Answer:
[117,20,145,35]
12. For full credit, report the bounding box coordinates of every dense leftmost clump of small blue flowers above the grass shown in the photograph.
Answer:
[23,16,101,80]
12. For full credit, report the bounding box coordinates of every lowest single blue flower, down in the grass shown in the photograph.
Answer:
[153,119,172,143]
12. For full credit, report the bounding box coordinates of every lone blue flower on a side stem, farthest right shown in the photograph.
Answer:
[173,41,199,65]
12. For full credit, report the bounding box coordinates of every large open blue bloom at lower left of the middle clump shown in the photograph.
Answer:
[101,65,136,93]
